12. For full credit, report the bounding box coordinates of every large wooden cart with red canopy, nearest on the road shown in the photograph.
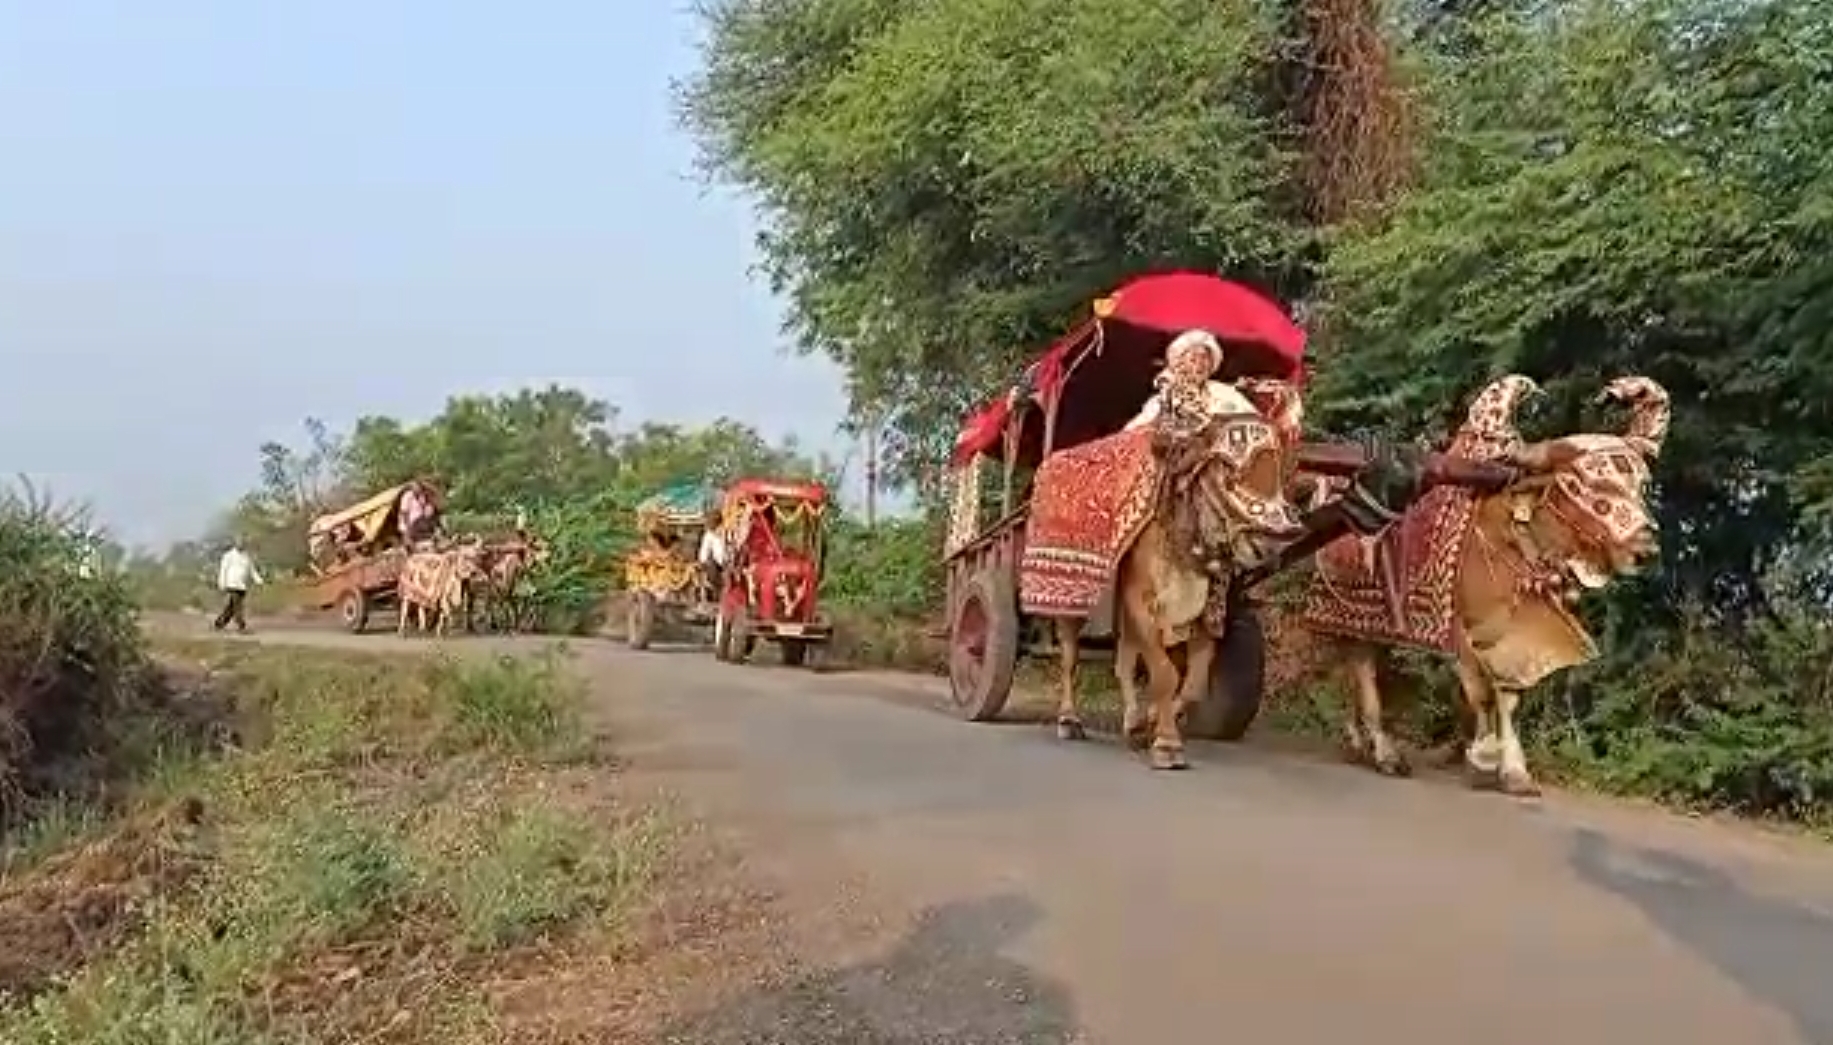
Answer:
[944,271,1512,739]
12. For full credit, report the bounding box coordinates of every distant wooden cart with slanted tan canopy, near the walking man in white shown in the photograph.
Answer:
[306,479,444,633]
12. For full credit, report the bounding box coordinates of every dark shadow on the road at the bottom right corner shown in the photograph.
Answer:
[1571,829,1833,1041]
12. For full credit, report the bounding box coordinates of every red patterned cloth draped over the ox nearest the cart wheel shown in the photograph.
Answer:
[1019,429,1160,616]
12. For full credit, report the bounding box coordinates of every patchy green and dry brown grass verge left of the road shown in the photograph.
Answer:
[0,642,675,1045]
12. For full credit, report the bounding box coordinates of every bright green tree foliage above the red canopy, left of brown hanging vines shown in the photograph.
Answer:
[684,0,1307,467]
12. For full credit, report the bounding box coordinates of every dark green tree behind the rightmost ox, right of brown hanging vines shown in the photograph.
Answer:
[1312,0,1833,620]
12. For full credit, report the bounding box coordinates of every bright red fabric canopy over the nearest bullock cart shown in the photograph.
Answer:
[955,271,1305,464]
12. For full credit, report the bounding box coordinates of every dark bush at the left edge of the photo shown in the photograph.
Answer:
[0,486,150,823]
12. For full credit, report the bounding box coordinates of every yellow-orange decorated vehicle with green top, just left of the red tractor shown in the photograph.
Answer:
[623,482,719,649]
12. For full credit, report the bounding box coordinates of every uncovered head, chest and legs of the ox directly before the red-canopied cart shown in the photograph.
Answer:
[1036,394,1300,770]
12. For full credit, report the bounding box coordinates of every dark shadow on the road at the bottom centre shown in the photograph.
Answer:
[662,895,1078,1045]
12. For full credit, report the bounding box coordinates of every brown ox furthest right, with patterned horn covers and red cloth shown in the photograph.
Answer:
[1301,376,1668,796]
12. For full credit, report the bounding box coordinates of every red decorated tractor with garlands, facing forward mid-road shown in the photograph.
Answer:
[713,479,834,667]
